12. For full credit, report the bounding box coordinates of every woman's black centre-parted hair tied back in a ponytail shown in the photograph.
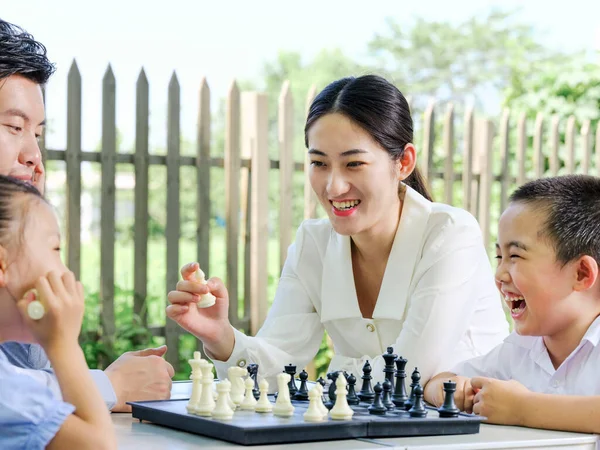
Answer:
[304,75,432,200]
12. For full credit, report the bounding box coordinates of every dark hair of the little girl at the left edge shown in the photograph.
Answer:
[0,175,45,244]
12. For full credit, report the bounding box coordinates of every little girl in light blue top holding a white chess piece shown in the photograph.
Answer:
[0,176,116,449]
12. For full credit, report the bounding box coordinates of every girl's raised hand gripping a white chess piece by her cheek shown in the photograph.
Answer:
[17,271,84,353]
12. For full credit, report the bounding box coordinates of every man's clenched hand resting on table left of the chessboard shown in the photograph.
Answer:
[104,345,175,412]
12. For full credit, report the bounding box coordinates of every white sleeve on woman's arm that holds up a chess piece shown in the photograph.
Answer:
[213,227,323,391]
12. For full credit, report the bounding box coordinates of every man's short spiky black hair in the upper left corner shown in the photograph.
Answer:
[0,19,55,84]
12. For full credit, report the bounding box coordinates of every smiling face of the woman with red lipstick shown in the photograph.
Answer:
[308,113,402,236]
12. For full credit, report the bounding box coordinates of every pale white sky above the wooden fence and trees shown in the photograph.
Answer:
[0,0,600,151]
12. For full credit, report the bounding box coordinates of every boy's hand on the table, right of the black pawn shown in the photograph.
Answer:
[471,377,531,425]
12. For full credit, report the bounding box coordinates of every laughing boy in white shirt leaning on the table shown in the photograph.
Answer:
[425,175,600,433]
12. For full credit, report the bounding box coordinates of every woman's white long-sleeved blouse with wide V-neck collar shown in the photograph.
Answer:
[214,187,508,390]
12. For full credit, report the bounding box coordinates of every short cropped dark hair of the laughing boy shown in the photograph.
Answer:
[510,175,600,264]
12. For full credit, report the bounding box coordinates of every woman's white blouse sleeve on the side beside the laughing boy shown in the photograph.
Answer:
[371,219,495,384]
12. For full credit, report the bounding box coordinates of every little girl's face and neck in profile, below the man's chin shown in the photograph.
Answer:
[0,194,67,342]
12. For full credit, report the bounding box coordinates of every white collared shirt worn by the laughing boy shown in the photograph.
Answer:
[451,317,600,395]
